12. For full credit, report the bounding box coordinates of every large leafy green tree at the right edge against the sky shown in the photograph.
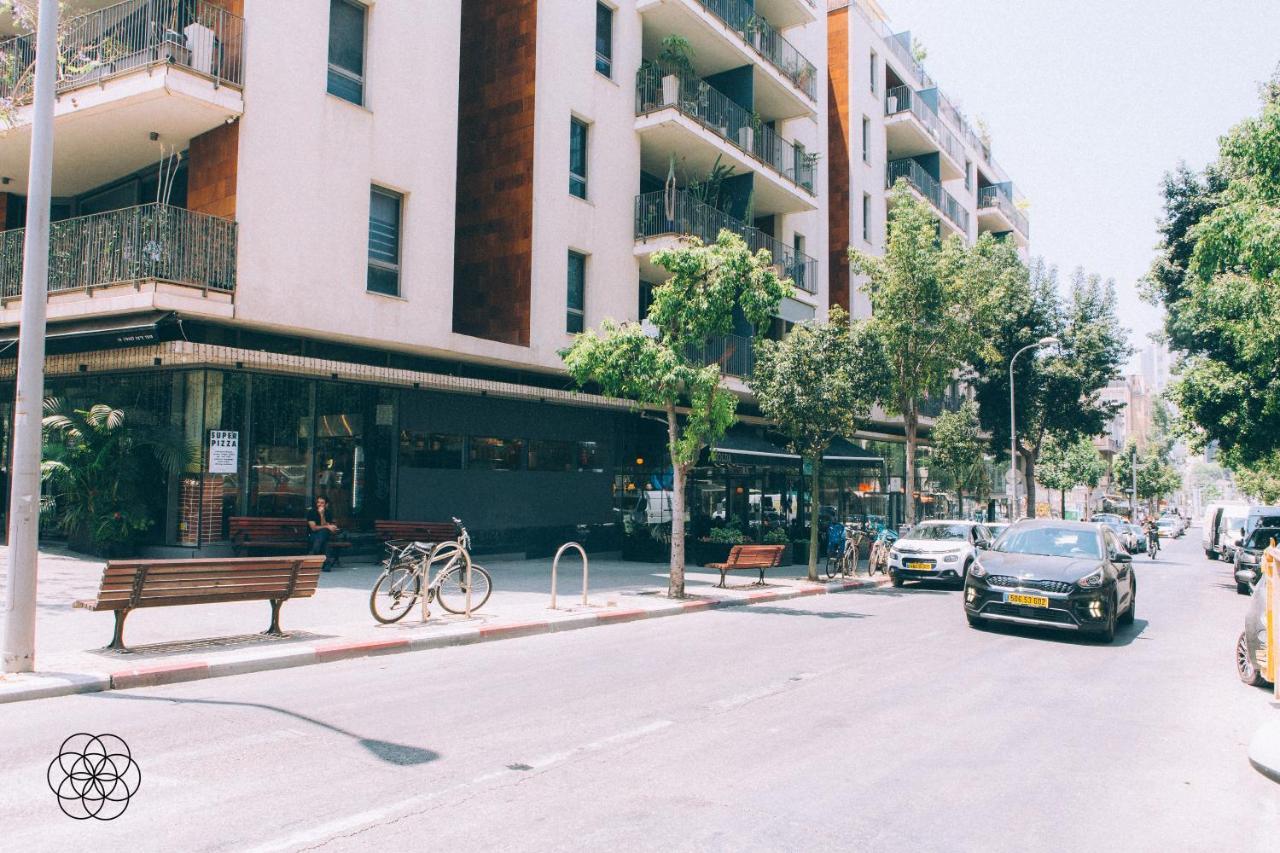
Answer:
[1146,74,1280,466]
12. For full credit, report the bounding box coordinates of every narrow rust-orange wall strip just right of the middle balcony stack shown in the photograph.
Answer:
[827,6,852,311]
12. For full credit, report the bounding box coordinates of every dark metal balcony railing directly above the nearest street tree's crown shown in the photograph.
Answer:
[635,190,818,293]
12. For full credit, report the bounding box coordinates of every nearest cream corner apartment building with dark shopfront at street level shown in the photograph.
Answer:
[0,0,834,551]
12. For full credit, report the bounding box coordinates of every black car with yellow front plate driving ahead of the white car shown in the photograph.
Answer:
[964,520,1138,643]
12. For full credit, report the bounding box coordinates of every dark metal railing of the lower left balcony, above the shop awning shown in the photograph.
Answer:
[0,204,236,300]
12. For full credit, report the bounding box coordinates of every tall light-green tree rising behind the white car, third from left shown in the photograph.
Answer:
[849,181,1012,524]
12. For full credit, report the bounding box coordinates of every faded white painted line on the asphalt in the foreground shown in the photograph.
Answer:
[250,720,675,853]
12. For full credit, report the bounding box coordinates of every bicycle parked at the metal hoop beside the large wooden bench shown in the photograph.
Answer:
[369,519,493,625]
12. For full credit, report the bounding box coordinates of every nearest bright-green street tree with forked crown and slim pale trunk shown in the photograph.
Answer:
[561,231,791,598]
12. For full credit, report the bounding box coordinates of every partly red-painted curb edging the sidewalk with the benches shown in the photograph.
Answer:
[0,578,890,706]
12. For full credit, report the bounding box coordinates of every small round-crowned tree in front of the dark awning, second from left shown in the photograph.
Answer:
[750,306,887,580]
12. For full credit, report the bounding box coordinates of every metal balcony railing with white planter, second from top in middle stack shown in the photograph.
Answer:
[636,64,815,195]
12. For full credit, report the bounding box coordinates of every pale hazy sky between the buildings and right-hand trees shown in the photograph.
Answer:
[881,0,1280,361]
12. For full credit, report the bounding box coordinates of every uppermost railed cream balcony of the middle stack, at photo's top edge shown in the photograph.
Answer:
[636,0,818,119]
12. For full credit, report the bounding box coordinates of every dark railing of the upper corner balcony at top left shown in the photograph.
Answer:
[0,0,244,104]
